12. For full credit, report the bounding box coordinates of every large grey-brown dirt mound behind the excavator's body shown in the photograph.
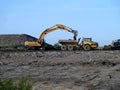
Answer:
[0,34,37,46]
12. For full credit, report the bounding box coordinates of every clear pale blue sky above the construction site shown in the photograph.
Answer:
[0,0,120,46]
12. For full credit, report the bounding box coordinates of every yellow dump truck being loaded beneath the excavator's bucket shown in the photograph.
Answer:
[59,38,98,51]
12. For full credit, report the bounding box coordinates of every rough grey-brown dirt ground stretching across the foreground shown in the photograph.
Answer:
[0,50,120,90]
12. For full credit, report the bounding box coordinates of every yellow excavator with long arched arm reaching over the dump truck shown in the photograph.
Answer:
[25,24,78,48]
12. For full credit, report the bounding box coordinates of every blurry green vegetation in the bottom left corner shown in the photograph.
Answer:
[0,77,32,90]
